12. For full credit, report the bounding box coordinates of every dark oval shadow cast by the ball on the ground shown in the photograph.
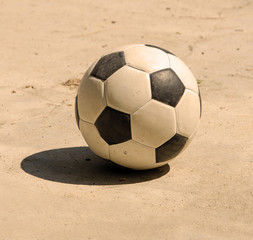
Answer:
[21,147,170,185]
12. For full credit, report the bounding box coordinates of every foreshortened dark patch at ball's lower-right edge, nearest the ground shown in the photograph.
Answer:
[155,133,188,163]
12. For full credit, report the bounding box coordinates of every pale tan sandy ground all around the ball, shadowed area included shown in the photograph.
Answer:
[0,0,253,240]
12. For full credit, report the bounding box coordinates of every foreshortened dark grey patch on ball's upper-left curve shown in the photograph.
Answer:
[90,52,126,81]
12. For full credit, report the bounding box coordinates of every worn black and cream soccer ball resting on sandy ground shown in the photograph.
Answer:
[75,44,201,170]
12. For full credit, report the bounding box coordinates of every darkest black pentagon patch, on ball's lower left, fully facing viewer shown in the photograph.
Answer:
[95,107,131,145]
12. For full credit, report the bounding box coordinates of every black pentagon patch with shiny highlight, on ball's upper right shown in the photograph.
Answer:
[150,68,185,107]
